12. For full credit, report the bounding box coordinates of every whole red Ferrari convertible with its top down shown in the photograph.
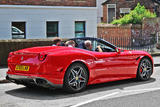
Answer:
[6,37,153,92]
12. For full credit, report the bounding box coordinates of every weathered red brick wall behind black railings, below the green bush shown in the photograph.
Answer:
[97,18,160,46]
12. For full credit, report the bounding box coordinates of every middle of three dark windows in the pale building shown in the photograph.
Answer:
[47,22,58,37]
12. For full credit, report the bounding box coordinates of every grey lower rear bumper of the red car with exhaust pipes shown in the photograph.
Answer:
[6,74,63,88]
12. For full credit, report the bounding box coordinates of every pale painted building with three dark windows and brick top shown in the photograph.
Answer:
[0,0,97,39]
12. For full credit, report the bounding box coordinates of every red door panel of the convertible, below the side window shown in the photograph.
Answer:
[95,52,119,79]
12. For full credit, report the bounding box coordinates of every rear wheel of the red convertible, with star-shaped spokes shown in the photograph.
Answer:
[63,63,88,93]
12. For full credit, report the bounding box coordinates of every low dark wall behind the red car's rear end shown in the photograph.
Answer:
[0,39,53,66]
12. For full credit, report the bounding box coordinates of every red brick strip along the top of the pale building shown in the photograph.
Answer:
[0,0,96,7]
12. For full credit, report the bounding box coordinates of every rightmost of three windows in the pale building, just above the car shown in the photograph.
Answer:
[75,21,85,38]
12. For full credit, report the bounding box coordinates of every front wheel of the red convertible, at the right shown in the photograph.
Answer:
[137,58,153,81]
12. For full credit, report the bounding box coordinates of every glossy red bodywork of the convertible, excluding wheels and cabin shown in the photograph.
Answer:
[7,37,153,92]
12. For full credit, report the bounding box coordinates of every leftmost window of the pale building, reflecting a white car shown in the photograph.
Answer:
[11,22,26,39]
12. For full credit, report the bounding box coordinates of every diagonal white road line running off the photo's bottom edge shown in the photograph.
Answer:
[70,92,120,107]
